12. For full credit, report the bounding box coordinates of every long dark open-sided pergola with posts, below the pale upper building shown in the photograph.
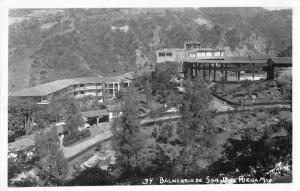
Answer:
[182,57,292,81]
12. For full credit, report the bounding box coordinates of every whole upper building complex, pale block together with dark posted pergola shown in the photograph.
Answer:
[156,41,292,82]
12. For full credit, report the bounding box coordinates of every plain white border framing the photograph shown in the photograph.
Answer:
[0,0,300,191]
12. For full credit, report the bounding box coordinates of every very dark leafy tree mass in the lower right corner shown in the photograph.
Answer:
[209,121,292,179]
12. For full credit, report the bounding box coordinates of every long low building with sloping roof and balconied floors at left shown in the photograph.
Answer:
[10,73,133,104]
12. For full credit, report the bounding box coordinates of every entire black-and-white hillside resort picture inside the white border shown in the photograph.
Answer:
[1,1,300,190]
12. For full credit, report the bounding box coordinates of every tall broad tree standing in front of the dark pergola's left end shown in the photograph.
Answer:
[177,77,217,176]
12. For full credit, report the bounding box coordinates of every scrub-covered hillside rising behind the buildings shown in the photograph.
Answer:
[9,8,292,91]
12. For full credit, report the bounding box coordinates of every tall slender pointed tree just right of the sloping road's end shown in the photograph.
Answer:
[111,85,144,179]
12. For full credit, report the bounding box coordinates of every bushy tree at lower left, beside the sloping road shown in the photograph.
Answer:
[35,127,68,186]
